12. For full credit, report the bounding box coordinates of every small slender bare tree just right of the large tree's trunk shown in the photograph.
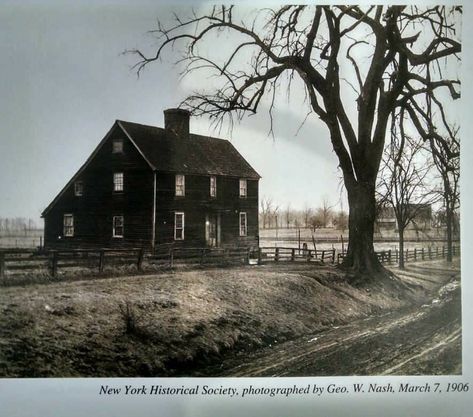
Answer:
[378,118,438,269]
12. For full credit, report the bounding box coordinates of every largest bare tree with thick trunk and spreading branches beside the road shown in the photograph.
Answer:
[130,5,461,278]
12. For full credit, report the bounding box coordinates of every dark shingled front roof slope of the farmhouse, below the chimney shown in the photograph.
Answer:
[117,120,260,179]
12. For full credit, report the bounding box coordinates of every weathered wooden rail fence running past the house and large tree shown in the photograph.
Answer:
[0,242,460,279]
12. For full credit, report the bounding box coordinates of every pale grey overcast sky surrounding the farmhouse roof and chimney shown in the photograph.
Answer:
[0,0,460,226]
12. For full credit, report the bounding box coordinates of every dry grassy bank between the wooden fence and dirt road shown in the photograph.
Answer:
[0,264,458,377]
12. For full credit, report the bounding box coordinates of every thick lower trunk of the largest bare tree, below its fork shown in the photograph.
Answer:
[343,182,384,279]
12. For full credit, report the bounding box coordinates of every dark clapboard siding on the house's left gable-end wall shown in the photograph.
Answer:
[45,127,153,247]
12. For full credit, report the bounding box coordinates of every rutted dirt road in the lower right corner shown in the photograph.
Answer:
[200,264,461,376]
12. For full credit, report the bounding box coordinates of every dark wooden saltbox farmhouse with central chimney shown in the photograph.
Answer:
[42,109,260,249]
